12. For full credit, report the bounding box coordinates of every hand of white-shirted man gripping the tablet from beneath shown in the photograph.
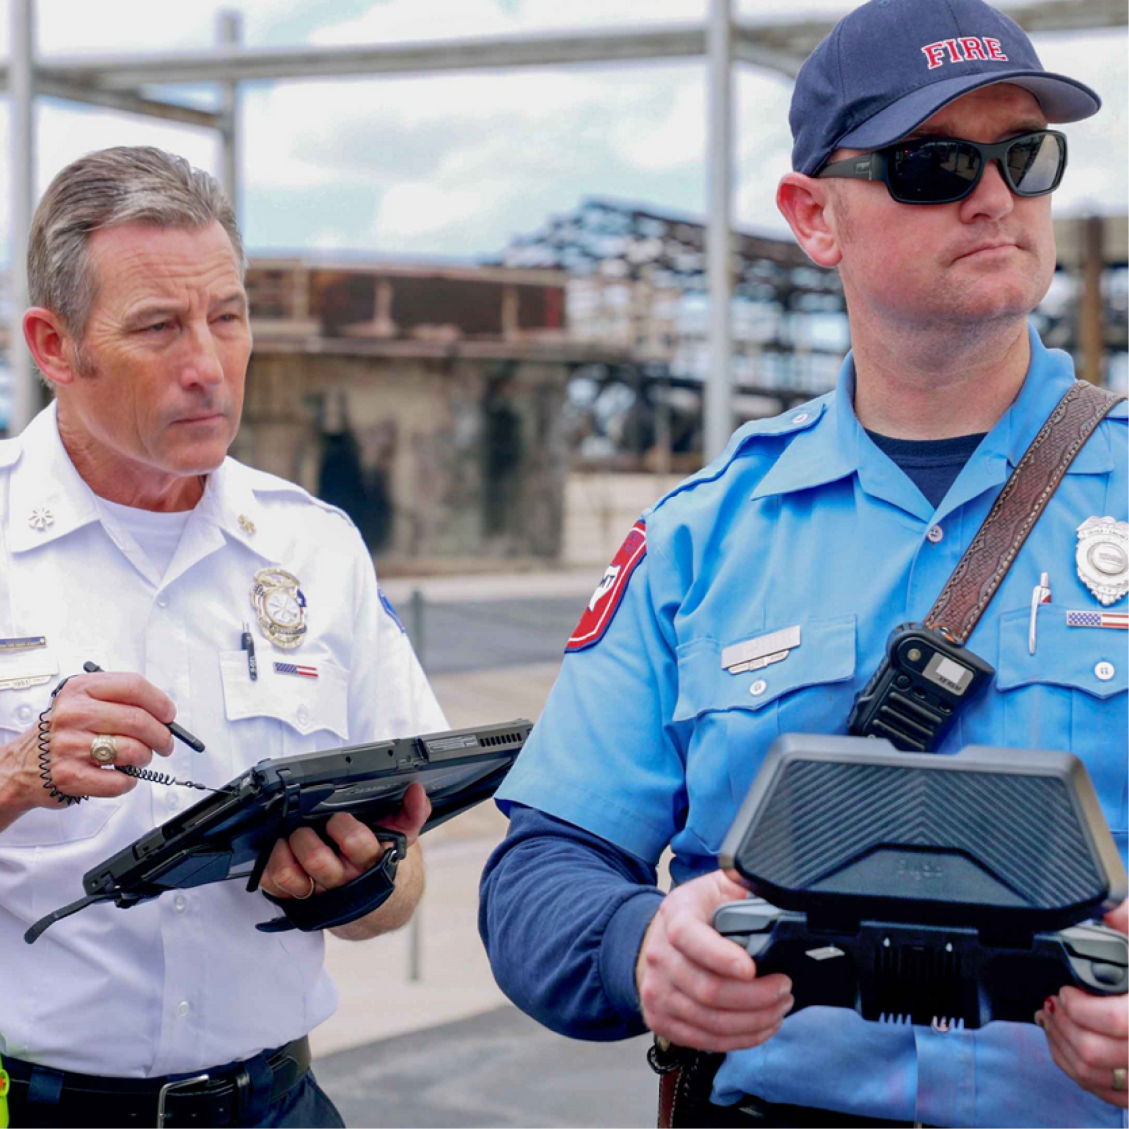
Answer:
[260,784,431,898]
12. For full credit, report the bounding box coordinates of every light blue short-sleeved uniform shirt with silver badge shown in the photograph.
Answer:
[499,322,1129,1129]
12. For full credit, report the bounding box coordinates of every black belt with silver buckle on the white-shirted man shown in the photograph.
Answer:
[3,1035,310,1129]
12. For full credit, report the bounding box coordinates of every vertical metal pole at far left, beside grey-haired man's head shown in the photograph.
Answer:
[8,0,37,435]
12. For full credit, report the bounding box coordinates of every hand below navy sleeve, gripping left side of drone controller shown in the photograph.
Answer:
[636,870,795,1051]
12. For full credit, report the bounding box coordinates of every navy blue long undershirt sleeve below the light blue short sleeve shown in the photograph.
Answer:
[479,804,663,1041]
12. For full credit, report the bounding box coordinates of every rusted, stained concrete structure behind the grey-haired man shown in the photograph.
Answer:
[233,259,625,572]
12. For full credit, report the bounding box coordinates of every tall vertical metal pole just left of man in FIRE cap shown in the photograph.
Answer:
[702,0,733,462]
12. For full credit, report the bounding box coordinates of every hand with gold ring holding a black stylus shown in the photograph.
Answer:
[0,671,176,830]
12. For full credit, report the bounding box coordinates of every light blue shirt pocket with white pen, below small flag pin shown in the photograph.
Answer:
[996,604,1129,831]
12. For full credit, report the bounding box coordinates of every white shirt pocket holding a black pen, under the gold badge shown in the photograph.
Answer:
[219,650,349,772]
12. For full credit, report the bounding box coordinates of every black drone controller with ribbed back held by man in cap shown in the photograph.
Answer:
[714,734,1129,1027]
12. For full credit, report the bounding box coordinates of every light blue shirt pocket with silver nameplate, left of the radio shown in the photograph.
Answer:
[673,614,856,855]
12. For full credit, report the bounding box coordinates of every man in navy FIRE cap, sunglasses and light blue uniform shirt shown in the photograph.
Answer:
[480,0,1129,1129]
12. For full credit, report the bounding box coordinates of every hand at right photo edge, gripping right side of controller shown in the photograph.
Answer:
[1035,902,1129,1109]
